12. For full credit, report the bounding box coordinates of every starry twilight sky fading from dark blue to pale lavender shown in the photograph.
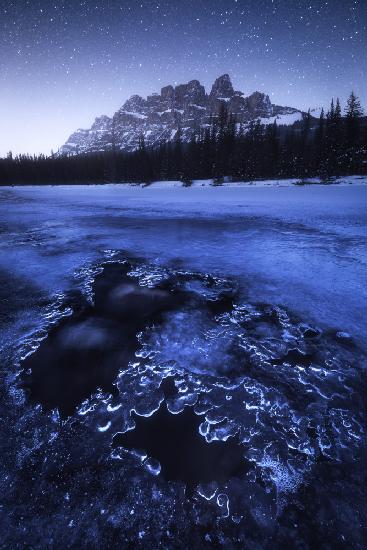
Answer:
[0,0,367,155]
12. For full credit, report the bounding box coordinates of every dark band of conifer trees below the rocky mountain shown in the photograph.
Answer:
[0,93,367,185]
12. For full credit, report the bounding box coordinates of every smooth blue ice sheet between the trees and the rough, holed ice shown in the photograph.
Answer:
[0,185,367,350]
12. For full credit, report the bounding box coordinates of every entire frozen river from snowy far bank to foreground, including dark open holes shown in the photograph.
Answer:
[0,179,367,548]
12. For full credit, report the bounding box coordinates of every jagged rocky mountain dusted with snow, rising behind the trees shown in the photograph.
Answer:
[59,74,302,155]
